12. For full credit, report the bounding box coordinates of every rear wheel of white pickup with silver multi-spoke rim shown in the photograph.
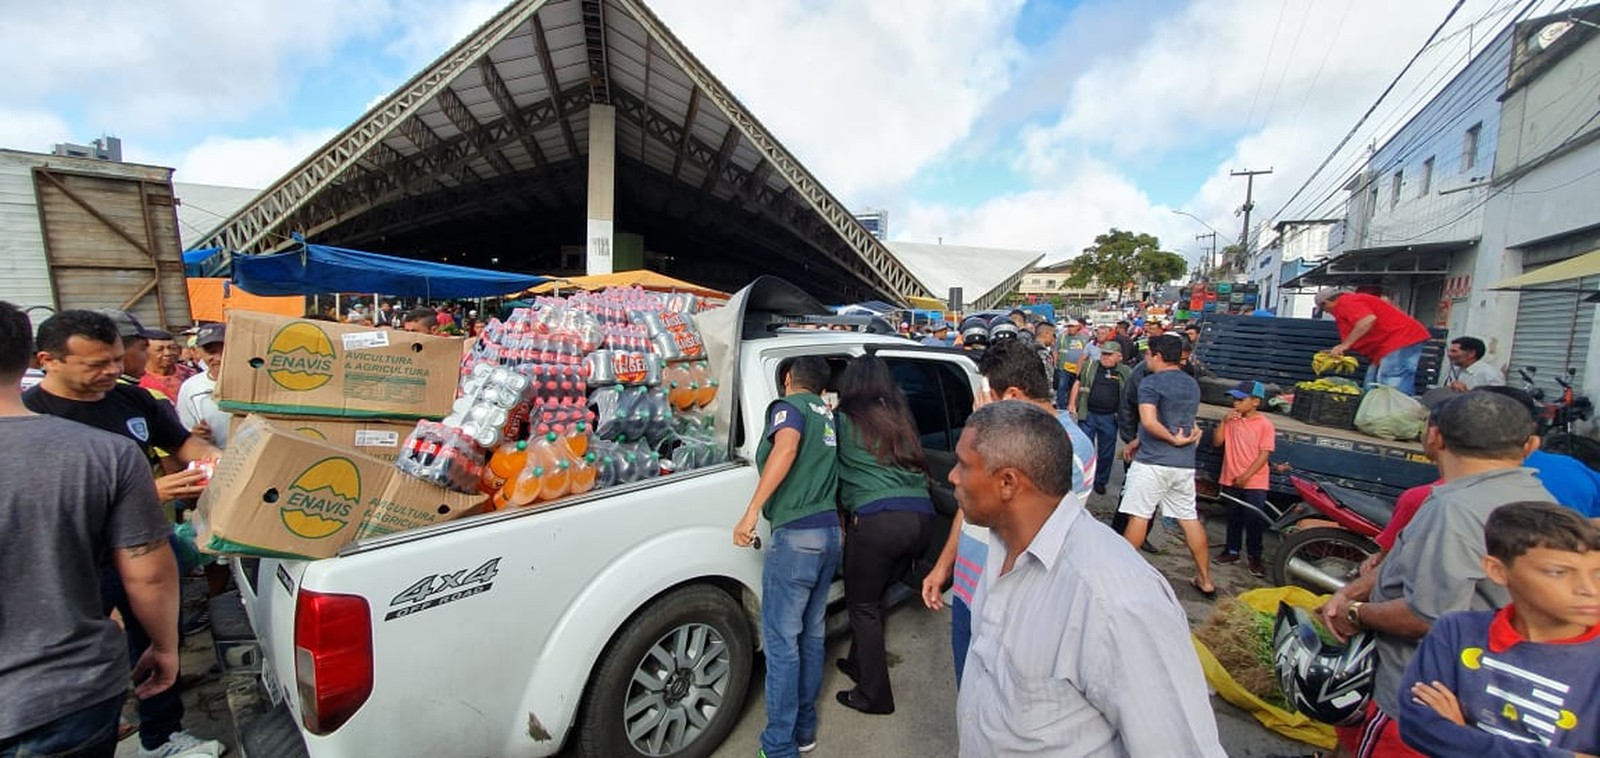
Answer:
[578,587,755,758]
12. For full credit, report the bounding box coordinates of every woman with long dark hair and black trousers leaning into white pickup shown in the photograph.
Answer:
[837,355,933,713]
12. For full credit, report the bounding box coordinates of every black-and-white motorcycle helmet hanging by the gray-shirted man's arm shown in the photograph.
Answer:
[1272,601,1378,726]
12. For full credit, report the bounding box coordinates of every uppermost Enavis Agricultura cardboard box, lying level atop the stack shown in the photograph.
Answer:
[216,310,462,419]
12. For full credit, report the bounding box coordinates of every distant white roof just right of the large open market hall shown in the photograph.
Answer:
[885,240,1045,310]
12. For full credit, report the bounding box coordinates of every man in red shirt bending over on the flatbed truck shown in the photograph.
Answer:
[1317,286,1432,395]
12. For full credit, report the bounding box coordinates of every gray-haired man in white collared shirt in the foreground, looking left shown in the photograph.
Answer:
[950,400,1227,758]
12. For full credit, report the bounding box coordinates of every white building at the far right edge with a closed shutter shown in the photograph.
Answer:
[1472,6,1600,395]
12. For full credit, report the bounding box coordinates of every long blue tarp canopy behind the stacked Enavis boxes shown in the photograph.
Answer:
[232,243,547,299]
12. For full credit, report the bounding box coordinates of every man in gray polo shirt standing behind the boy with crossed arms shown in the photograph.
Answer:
[1320,390,1555,758]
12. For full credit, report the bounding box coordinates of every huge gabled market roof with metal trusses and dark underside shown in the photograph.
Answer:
[194,0,930,302]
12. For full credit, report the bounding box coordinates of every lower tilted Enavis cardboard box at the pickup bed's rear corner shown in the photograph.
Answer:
[197,416,483,558]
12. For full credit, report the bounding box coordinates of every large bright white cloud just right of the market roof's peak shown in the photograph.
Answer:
[653,0,1022,201]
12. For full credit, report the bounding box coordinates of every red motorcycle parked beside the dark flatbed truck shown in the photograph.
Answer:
[1254,473,1395,593]
